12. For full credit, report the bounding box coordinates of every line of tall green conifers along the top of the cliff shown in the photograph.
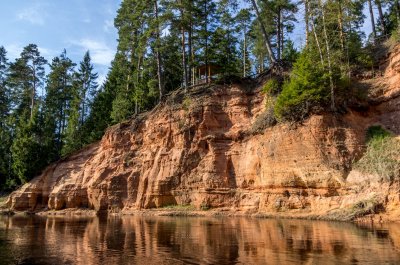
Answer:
[0,0,400,189]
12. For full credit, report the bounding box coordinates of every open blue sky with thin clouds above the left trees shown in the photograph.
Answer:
[0,0,121,83]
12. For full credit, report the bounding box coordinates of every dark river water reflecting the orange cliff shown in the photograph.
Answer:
[0,216,400,265]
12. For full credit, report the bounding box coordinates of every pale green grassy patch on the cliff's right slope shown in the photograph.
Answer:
[354,126,400,181]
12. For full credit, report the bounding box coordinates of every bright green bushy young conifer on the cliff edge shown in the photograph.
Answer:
[274,52,329,120]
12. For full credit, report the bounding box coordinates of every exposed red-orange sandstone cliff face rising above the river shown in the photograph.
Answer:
[7,46,400,218]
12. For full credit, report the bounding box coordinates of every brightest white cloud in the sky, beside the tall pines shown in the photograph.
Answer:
[71,39,115,66]
